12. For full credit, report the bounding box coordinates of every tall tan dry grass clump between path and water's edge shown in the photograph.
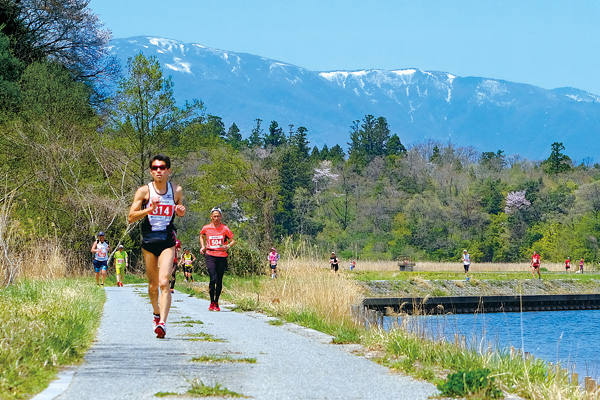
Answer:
[229,259,363,322]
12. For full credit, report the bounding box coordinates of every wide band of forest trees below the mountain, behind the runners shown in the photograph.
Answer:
[0,0,600,276]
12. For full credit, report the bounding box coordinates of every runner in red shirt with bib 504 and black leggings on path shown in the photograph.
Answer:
[200,207,235,311]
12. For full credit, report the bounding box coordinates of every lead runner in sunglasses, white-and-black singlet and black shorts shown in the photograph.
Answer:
[127,154,185,338]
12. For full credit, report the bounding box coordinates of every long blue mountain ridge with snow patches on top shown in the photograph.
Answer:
[112,37,600,160]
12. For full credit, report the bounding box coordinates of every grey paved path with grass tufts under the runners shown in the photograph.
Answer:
[39,286,438,400]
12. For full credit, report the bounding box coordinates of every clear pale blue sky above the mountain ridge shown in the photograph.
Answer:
[90,0,600,95]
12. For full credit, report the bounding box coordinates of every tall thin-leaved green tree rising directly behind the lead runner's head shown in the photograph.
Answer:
[109,53,205,186]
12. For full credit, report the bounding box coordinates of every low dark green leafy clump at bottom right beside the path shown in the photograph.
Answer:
[437,368,502,399]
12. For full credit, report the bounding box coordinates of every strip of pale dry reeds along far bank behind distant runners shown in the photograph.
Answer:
[352,260,568,272]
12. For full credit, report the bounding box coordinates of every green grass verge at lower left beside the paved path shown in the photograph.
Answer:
[0,279,106,399]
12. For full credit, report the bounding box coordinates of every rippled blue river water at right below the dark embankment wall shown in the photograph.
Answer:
[384,310,600,382]
